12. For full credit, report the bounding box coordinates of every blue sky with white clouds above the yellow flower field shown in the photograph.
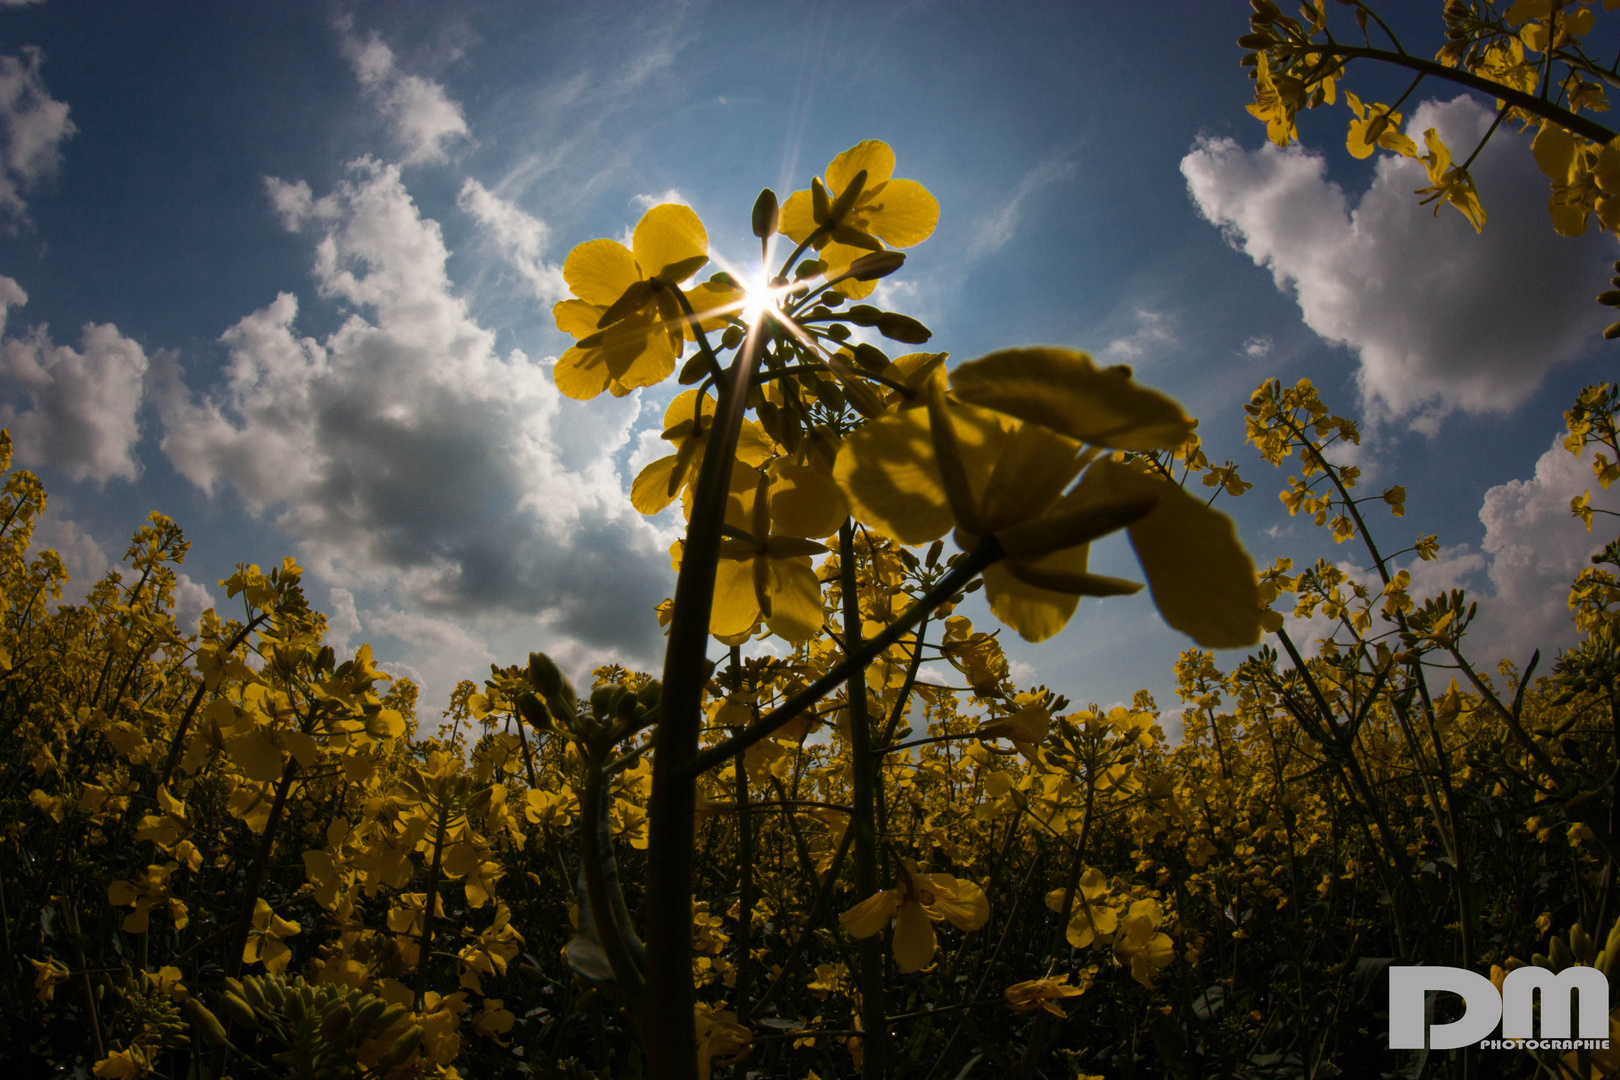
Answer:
[0,0,1615,725]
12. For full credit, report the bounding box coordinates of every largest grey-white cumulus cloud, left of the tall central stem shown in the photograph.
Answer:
[152,159,671,695]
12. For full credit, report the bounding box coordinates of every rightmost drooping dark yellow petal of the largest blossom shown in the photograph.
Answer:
[1085,460,1260,649]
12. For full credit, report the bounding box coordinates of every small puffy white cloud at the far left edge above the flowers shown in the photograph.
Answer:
[0,277,147,483]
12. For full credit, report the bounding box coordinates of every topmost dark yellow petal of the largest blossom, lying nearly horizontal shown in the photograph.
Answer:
[951,348,1192,450]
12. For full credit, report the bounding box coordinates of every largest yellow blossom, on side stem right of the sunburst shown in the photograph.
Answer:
[834,348,1260,648]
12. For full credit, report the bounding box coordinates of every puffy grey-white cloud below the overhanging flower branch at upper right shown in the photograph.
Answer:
[1181,97,1605,432]
